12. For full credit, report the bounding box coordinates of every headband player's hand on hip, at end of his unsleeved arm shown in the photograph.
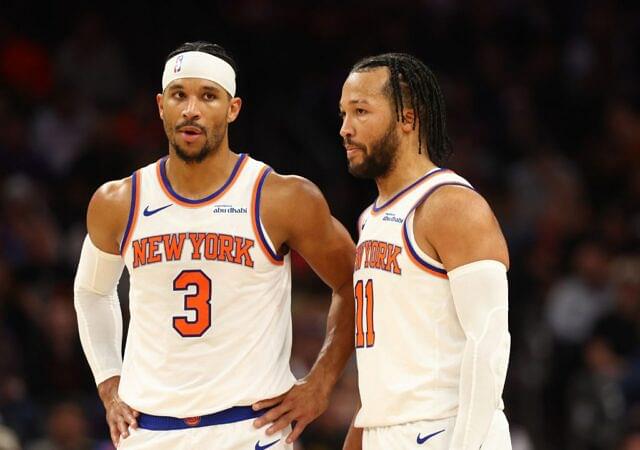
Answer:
[252,377,331,444]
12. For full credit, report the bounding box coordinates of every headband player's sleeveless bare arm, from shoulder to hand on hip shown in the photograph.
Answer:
[255,175,355,442]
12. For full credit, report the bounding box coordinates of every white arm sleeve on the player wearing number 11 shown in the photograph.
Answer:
[448,260,511,450]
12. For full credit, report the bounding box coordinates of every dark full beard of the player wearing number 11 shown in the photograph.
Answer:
[345,121,400,179]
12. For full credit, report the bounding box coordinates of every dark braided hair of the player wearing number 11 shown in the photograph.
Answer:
[351,53,452,165]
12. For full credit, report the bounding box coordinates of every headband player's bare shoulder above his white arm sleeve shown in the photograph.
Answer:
[87,177,132,253]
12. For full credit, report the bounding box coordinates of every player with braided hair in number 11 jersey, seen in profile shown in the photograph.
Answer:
[340,53,511,450]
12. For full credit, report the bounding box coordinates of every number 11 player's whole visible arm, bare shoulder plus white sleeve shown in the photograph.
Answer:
[414,186,510,450]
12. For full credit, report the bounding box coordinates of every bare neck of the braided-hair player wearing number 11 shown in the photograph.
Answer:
[376,145,436,204]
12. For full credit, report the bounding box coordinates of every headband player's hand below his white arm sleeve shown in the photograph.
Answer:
[98,376,140,447]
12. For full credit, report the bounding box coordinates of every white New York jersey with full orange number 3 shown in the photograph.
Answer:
[119,154,295,418]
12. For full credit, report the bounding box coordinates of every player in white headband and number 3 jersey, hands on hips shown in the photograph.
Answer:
[75,42,355,450]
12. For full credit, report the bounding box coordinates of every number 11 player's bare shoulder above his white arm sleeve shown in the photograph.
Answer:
[414,186,509,270]
